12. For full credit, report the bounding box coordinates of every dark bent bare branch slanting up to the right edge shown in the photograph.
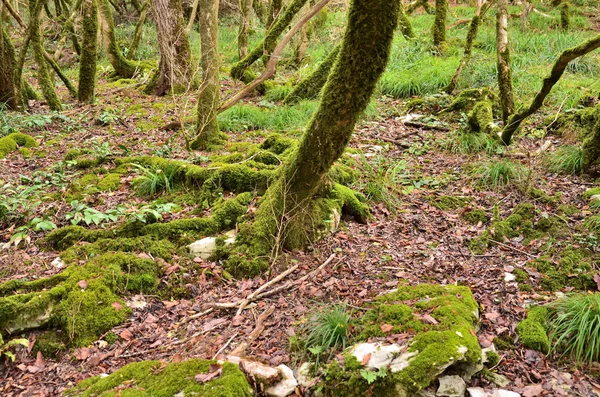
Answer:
[502,35,600,145]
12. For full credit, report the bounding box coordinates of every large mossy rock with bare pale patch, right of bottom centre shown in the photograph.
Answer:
[323,284,483,397]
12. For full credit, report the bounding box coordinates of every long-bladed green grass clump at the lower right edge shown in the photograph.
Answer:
[549,293,600,364]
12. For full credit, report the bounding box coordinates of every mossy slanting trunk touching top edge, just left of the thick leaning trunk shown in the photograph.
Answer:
[231,0,308,82]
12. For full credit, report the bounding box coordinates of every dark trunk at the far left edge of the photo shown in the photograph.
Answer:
[0,24,20,110]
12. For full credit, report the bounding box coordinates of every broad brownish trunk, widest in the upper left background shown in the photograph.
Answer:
[152,0,192,95]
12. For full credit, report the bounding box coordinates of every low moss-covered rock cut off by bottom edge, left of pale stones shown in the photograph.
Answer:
[65,359,254,397]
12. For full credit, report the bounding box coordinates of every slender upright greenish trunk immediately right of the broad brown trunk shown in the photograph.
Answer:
[191,0,223,150]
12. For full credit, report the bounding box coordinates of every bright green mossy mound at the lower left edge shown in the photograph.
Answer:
[0,253,160,346]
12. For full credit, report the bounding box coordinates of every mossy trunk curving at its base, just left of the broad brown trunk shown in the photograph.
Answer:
[98,0,137,79]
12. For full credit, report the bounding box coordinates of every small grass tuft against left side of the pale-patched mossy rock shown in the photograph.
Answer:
[304,304,352,367]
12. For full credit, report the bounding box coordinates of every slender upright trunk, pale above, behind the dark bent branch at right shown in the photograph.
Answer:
[496,0,515,124]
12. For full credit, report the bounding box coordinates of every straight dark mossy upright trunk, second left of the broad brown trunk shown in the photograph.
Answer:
[78,0,98,102]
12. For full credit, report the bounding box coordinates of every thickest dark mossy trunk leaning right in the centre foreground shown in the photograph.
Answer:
[241,0,399,254]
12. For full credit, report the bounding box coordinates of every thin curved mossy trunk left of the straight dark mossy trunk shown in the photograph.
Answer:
[29,0,62,111]
